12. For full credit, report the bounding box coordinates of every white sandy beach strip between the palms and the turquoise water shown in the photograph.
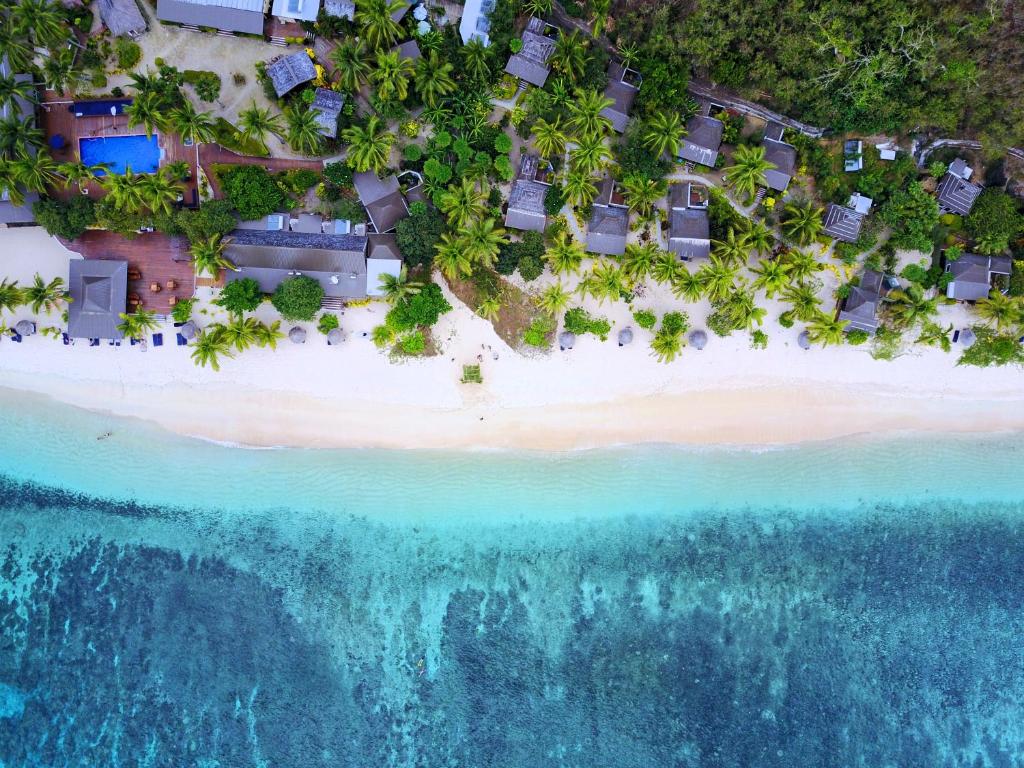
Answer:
[0,229,1024,451]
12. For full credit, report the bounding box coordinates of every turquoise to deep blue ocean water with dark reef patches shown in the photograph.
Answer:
[0,390,1024,768]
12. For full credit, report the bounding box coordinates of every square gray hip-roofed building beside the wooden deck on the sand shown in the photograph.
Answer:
[68,259,128,339]
